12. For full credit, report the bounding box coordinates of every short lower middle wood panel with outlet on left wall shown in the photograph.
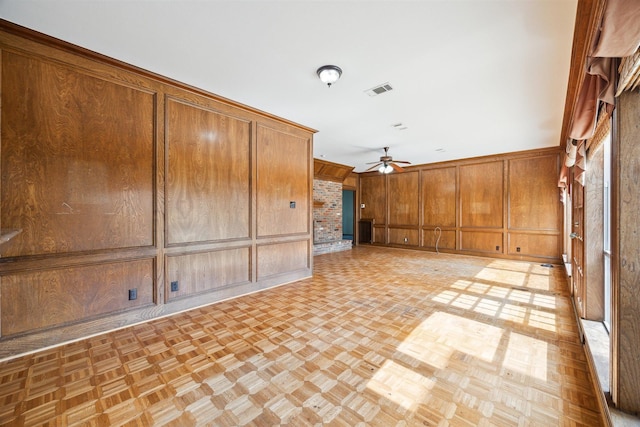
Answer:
[166,248,251,300]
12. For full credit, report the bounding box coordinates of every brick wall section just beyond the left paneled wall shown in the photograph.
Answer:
[313,179,342,243]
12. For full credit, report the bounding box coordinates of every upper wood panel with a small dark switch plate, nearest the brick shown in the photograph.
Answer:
[257,125,313,237]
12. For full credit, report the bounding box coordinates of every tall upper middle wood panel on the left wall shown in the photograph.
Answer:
[166,98,251,245]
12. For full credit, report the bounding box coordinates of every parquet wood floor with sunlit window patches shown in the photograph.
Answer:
[0,246,602,427]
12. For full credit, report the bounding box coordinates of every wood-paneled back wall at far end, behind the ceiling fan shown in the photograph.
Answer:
[359,148,562,262]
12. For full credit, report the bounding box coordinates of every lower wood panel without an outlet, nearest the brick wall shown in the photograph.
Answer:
[257,241,311,280]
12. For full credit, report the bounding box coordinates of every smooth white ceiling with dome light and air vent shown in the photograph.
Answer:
[0,0,577,171]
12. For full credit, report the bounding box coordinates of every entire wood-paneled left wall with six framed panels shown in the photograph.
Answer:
[0,21,314,358]
